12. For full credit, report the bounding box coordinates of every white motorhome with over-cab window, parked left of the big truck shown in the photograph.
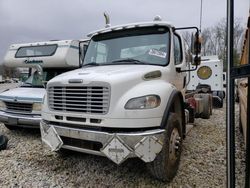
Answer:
[0,40,87,130]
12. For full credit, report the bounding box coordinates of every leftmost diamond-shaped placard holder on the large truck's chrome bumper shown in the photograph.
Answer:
[40,125,63,151]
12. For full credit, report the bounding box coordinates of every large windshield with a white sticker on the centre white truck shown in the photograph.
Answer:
[83,27,169,66]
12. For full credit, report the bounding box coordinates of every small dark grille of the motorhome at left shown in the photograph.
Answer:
[5,102,32,113]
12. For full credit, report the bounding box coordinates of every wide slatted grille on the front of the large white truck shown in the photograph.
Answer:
[48,86,109,114]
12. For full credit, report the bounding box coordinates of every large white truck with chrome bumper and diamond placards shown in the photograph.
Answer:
[40,19,212,181]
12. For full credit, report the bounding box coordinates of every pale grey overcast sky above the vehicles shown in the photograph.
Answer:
[0,0,249,62]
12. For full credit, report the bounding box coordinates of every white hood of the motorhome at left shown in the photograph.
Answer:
[0,87,45,102]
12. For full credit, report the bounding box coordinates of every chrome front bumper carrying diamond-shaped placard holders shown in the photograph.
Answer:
[40,120,165,164]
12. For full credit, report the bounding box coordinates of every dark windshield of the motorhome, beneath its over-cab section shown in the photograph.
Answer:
[22,69,69,88]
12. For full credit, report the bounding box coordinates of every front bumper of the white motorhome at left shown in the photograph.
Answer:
[0,111,41,128]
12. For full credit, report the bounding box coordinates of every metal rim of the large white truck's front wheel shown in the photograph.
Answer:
[169,128,181,162]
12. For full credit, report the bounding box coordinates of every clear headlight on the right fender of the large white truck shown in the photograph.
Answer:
[125,95,161,110]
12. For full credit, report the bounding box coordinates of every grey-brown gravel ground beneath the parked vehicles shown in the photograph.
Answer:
[0,105,244,188]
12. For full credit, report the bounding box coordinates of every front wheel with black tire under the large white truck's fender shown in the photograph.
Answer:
[147,113,183,182]
